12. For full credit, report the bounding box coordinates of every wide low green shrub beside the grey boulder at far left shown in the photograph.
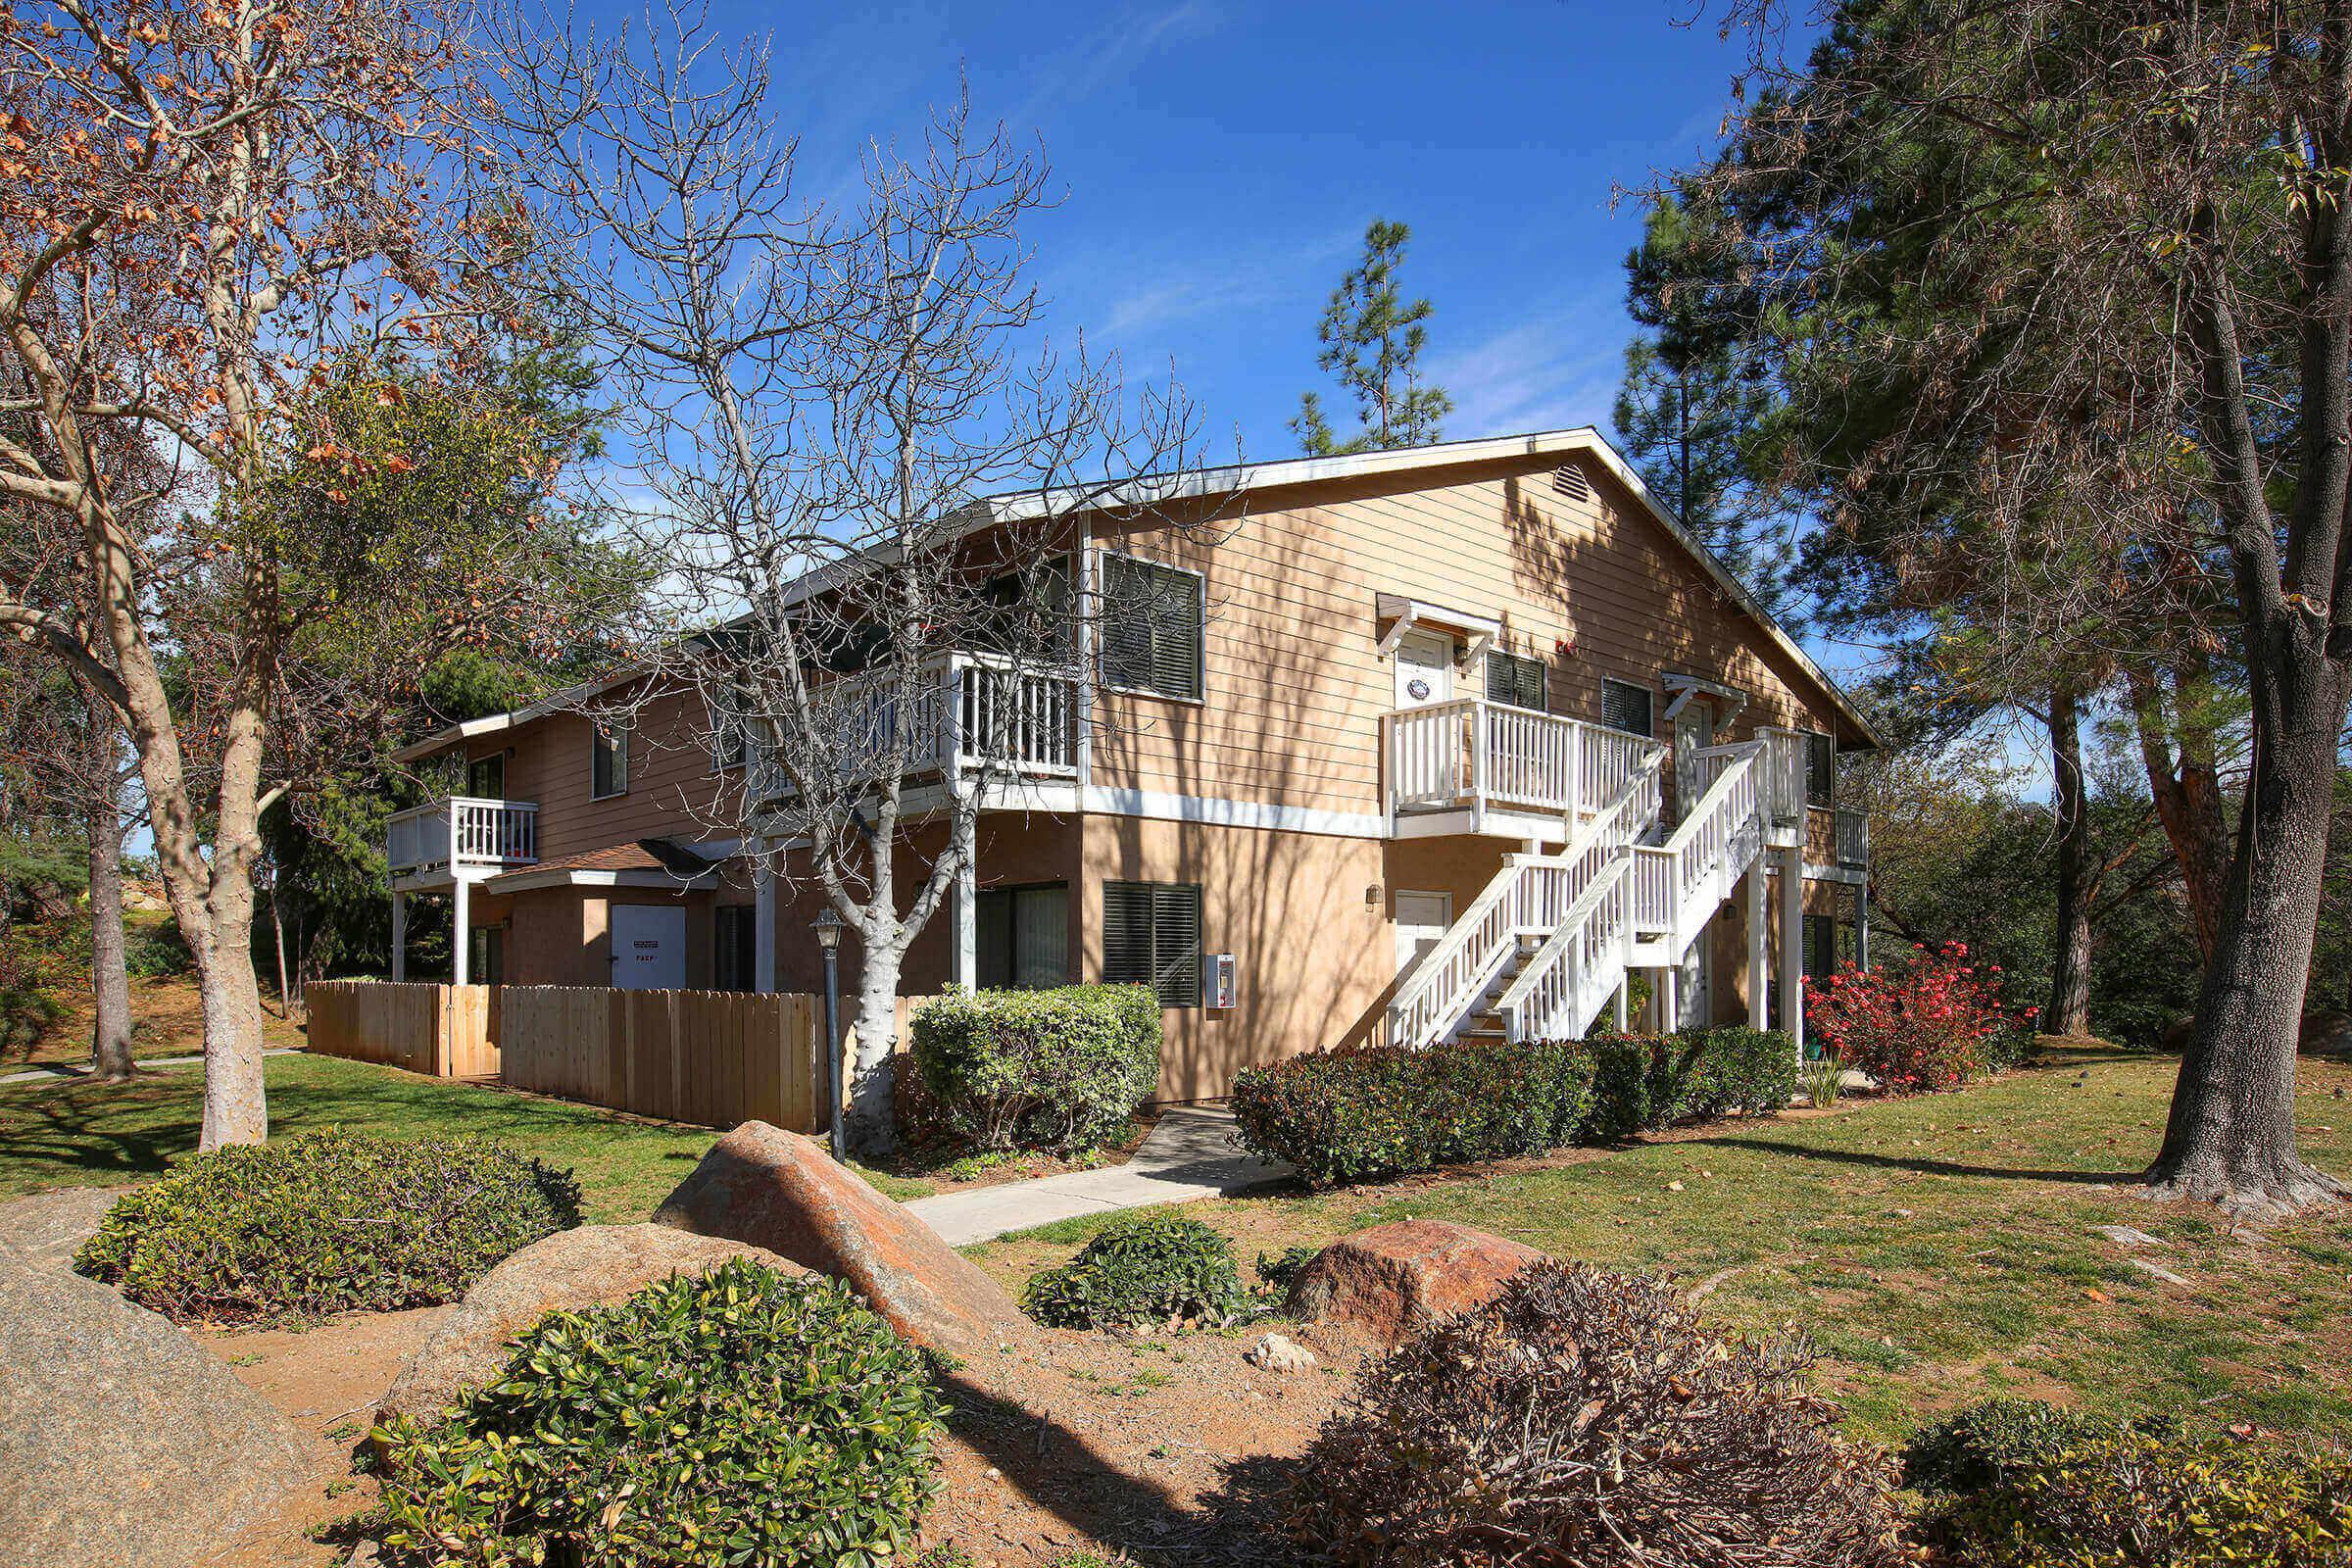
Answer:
[73,1131,581,1321]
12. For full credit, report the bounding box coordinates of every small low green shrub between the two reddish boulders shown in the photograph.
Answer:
[1021,1213,1260,1328]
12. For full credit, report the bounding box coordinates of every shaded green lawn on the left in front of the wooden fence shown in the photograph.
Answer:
[0,1055,931,1222]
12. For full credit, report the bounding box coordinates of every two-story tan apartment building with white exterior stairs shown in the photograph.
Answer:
[388,430,1875,1098]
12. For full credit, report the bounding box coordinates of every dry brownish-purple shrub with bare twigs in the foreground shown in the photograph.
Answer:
[1292,1262,1903,1568]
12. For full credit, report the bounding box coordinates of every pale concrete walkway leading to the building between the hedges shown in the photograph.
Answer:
[907,1104,1292,1246]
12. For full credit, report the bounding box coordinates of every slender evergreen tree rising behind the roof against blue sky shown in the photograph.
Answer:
[1292,219,1453,456]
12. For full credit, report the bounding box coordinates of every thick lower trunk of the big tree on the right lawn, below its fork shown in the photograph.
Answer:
[2145,630,2345,1218]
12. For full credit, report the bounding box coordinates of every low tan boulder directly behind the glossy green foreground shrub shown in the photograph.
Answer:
[376,1225,802,1420]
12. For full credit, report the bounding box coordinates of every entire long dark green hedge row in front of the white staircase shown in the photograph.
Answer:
[1233,1025,1797,1185]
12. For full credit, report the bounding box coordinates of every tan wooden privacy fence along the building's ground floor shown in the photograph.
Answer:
[308,980,929,1133]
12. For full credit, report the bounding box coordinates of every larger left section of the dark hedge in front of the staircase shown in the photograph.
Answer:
[1233,1039,1592,1185]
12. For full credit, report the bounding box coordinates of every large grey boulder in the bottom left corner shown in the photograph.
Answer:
[0,1246,318,1568]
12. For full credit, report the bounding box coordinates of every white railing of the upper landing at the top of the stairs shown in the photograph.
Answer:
[1381,696,1665,815]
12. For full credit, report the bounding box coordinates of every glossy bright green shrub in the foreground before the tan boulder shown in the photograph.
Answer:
[376,1257,946,1568]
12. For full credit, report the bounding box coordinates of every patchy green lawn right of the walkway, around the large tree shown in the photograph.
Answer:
[969,1051,2352,1437]
